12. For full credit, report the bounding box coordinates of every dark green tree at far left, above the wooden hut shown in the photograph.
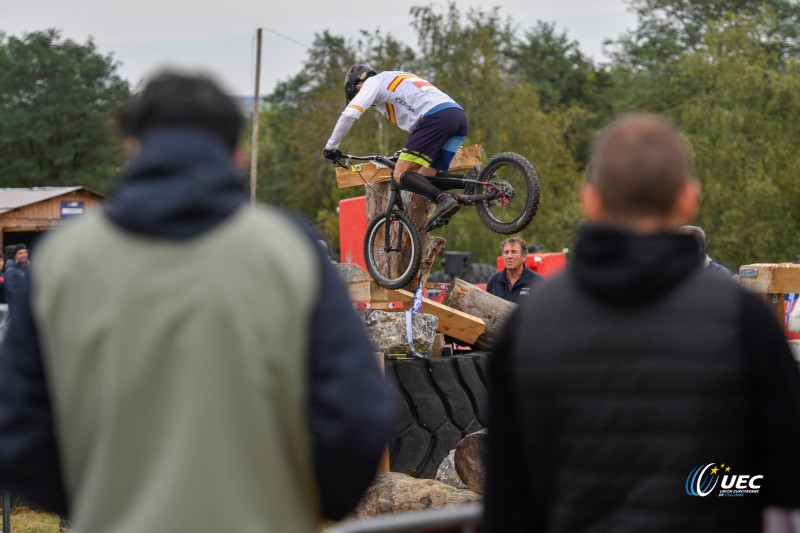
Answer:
[0,29,130,191]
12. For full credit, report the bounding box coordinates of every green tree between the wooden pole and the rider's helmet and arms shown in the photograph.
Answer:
[258,31,414,244]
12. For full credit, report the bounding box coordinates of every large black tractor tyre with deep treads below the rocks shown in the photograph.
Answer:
[386,352,489,478]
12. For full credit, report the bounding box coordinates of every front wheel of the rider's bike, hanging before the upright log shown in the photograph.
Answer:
[364,211,422,289]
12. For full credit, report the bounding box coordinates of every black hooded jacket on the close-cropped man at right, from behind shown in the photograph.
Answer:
[486,222,800,533]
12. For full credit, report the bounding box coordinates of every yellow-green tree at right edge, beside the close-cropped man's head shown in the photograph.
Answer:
[671,15,800,267]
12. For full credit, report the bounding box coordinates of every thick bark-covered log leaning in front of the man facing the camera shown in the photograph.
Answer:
[443,278,517,350]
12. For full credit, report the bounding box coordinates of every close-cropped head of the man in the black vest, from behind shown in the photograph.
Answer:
[588,114,693,219]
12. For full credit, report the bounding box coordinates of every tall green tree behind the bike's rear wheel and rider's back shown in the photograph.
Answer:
[411,3,580,262]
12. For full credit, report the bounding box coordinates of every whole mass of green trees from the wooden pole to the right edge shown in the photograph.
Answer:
[252,0,800,268]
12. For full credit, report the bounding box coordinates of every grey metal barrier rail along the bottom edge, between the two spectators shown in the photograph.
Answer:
[327,503,483,533]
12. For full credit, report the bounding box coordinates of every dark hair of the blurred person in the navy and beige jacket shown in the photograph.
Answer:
[118,71,244,151]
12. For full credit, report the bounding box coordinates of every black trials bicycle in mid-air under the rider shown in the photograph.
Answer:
[334,152,541,289]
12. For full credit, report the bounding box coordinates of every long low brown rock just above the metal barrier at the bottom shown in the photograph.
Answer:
[350,472,481,518]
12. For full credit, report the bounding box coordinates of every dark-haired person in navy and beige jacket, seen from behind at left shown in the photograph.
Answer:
[0,72,392,533]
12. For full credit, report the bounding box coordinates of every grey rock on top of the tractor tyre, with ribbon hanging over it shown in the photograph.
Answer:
[365,311,439,355]
